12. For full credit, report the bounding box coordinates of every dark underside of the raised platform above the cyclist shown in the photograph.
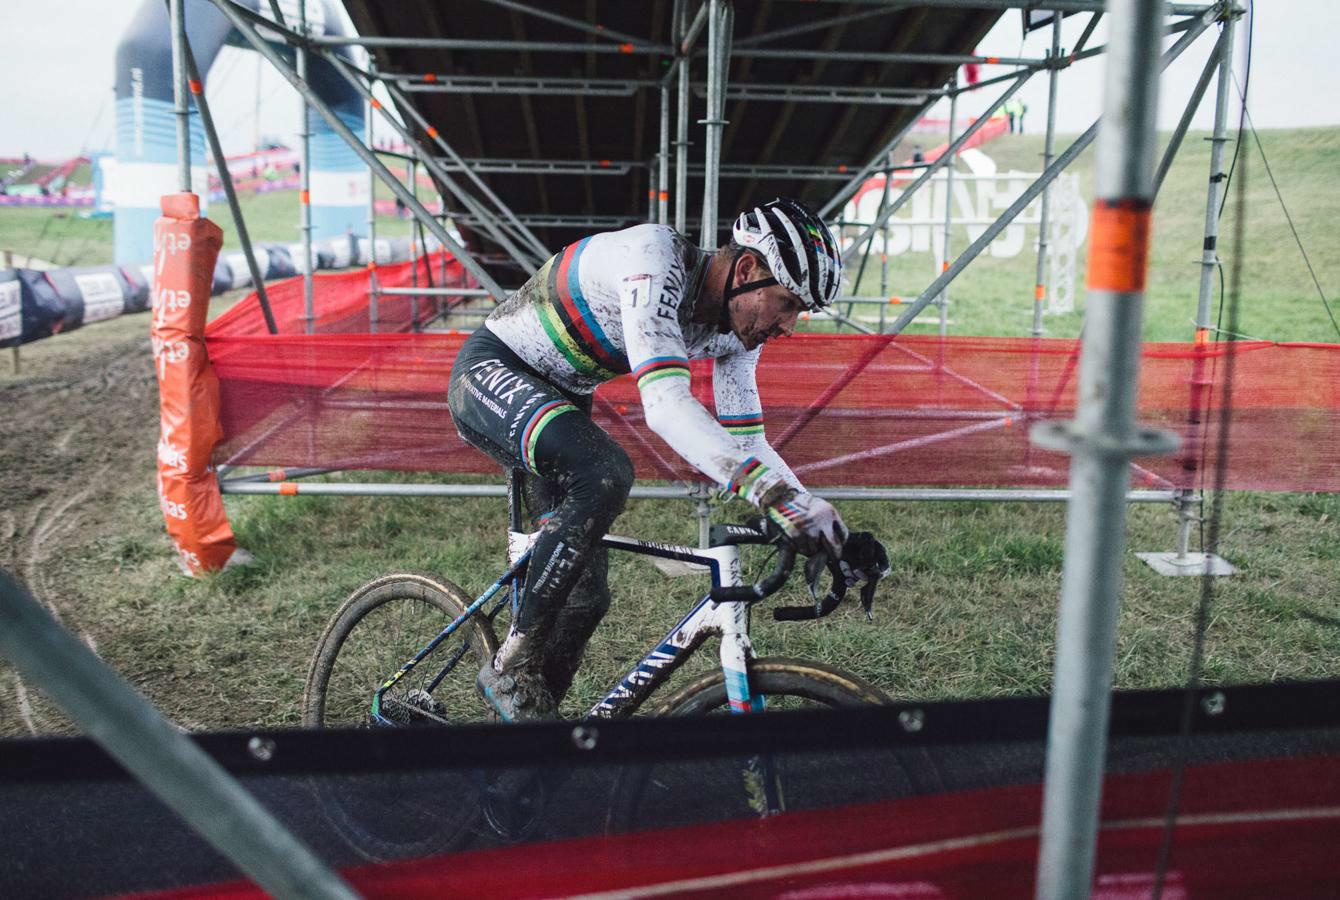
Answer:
[344,0,1002,277]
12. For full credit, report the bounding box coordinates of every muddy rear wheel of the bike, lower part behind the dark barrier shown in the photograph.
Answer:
[303,575,497,863]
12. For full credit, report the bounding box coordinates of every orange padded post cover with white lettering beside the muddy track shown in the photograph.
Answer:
[150,193,237,575]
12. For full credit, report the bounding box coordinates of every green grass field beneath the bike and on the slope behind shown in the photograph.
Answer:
[0,129,1340,735]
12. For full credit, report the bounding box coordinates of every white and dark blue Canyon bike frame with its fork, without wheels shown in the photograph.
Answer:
[371,532,765,726]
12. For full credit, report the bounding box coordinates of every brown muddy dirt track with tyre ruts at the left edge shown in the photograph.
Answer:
[0,315,158,737]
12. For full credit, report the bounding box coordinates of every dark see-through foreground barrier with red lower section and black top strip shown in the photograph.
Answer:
[0,682,1340,899]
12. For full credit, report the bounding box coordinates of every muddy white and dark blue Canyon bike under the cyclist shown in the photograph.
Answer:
[303,479,911,858]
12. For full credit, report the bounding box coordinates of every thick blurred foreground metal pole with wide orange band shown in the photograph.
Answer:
[1032,0,1177,900]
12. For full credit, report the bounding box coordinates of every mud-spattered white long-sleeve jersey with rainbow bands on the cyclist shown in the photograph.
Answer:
[484,225,800,498]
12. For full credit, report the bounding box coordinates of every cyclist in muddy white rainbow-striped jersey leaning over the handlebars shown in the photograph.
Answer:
[448,198,868,721]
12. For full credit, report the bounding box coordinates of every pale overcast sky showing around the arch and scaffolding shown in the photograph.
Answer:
[0,0,1340,159]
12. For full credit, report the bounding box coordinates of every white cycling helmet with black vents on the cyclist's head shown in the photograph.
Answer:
[732,197,842,309]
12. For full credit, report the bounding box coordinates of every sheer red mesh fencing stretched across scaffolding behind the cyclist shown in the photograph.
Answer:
[209,297,1340,492]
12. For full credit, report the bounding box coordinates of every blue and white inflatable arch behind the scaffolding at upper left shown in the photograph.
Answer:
[107,0,369,264]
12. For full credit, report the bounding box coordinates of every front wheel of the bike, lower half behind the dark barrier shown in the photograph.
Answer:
[606,658,938,833]
